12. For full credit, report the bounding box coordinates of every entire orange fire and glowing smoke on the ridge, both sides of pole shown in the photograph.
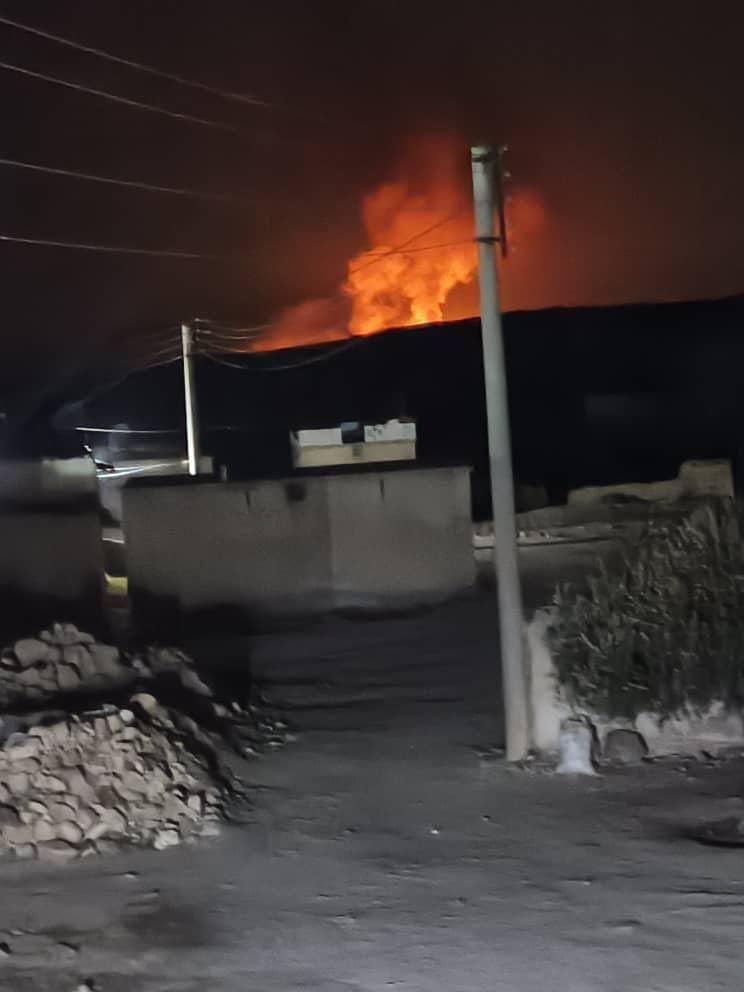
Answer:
[259,144,545,349]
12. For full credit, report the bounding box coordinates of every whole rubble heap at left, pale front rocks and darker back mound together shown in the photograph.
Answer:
[0,624,280,861]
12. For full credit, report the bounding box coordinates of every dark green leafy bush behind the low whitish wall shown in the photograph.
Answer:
[551,502,744,718]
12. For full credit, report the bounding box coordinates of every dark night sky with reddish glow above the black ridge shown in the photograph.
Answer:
[0,0,744,404]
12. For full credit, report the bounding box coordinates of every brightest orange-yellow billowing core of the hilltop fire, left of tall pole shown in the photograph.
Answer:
[343,183,477,334]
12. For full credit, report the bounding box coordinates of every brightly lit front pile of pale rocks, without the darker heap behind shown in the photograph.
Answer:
[0,693,227,861]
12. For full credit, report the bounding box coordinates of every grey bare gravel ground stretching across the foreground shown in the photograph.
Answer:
[0,580,744,992]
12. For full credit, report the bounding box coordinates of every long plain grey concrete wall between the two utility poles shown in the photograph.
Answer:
[124,468,474,624]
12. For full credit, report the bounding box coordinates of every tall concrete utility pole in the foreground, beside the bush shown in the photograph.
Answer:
[470,146,529,761]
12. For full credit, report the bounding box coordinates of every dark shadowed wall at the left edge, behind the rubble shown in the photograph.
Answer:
[0,458,104,636]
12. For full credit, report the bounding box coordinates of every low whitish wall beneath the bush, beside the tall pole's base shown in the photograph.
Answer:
[525,609,744,757]
